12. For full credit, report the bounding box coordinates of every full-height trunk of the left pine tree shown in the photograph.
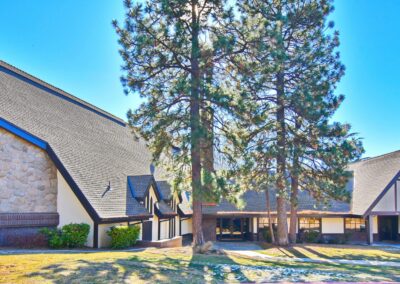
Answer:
[190,1,204,246]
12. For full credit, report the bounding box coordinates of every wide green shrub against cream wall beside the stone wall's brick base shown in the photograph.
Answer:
[39,223,90,248]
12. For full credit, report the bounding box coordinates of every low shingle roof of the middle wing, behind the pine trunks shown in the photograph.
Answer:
[203,190,350,215]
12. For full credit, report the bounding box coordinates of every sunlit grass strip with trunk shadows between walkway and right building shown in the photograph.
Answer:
[258,244,400,262]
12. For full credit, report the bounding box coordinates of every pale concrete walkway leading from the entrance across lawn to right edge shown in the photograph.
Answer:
[214,242,400,268]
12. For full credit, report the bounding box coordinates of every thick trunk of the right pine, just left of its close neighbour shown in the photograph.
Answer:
[276,72,288,246]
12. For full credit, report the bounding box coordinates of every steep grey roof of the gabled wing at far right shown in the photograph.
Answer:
[349,151,400,215]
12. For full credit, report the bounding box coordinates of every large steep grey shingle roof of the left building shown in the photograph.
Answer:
[0,61,166,219]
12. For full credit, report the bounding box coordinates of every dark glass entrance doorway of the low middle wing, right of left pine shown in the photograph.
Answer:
[216,218,249,241]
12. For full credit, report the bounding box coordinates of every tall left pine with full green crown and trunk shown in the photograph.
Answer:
[113,0,245,245]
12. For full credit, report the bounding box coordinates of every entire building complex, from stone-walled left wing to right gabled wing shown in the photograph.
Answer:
[0,61,400,247]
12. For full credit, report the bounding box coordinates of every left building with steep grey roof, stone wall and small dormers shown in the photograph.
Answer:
[0,61,192,247]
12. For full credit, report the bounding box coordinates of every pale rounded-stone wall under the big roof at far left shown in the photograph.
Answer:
[0,128,57,213]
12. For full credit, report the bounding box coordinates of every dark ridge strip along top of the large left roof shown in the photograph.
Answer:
[0,59,126,126]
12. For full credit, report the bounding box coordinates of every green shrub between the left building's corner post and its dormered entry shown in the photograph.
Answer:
[107,225,140,249]
